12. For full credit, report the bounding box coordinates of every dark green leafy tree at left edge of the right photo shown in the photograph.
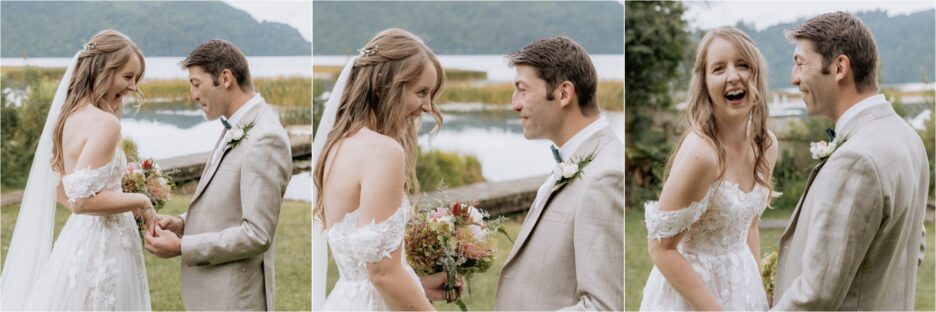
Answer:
[624,1,691,207]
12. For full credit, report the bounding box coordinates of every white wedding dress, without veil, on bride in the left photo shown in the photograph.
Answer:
[24,149,150,311]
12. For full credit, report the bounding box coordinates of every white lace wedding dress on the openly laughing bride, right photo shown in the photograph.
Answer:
[640,181,768,311]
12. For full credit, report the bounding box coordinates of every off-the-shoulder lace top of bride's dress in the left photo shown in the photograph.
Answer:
[62,148,127,202]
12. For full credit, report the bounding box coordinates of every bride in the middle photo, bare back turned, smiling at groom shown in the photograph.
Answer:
[313,29,444,310]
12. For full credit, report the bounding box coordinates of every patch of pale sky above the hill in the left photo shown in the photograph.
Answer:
[224,0,312,42]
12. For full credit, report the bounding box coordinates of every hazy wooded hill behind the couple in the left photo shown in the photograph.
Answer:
[0,1,311,57]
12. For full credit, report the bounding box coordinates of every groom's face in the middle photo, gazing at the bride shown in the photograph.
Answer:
[510,64,562,140]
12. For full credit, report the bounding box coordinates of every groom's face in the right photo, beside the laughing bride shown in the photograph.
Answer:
[790,39,838,117]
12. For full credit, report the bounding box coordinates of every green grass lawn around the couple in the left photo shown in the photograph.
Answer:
[0,194,312,310]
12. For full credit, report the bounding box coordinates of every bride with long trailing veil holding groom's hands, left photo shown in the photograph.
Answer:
[0,30,155,310]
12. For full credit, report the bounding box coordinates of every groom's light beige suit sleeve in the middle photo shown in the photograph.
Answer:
[561,168,624,311]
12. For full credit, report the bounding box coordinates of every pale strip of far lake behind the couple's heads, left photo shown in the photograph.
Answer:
[0,56,312,79]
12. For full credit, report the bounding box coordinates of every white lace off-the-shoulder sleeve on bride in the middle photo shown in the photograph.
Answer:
[347,208,406,263]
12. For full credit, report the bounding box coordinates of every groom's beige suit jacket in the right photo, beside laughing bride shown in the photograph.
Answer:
[773,103,929,310]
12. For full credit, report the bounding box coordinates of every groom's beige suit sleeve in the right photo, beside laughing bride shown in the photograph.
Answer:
[773,151,884,310]
